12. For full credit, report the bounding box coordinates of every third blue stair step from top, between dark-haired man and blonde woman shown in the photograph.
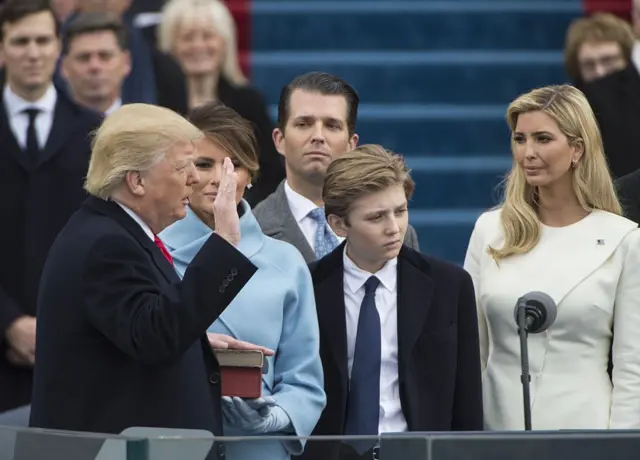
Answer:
[271,104,510,157]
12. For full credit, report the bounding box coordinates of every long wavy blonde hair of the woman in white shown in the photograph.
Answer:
[489,85,622,261]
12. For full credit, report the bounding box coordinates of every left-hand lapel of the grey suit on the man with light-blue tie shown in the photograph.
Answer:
[264,181,316,263]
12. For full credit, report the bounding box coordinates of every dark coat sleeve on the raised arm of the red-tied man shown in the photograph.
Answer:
[82,234,257,364]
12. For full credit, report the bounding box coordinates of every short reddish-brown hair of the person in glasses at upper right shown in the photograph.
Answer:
[564,13,636,82]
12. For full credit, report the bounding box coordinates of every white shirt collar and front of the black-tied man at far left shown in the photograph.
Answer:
[3,84,58,150]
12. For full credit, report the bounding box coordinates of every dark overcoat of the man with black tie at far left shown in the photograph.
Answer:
[0,91,101,412]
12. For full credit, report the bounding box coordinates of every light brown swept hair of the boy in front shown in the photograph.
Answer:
[322,144,415,222]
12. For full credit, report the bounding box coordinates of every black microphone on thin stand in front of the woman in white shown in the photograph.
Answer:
[513,291,558,431]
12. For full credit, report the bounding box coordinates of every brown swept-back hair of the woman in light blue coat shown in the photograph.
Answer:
[189,101,260,181]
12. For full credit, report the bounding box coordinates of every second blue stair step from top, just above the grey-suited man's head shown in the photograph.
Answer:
[252,51,566,104]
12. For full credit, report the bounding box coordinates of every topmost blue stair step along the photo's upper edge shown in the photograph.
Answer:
[251,0,583,51]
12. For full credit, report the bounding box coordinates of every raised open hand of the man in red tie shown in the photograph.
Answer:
[213,157,240,246]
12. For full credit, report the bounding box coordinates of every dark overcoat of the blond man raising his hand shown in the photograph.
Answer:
[30,197,256,442]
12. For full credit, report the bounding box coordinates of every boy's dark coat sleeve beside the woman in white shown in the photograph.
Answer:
[451,272,484,431]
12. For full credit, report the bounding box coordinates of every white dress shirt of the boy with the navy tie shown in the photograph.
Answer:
[343,247,407,433]
